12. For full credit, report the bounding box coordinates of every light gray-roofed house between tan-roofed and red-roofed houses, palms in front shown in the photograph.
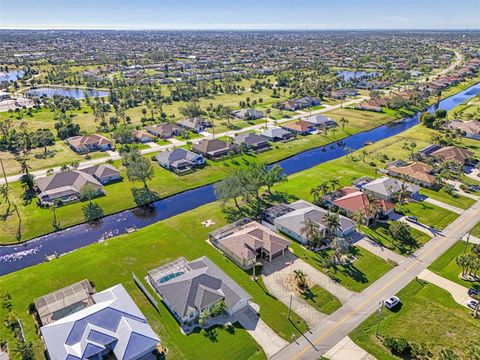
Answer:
[273,200,356,244]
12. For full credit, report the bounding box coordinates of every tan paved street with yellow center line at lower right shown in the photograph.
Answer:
[272,197,480,360]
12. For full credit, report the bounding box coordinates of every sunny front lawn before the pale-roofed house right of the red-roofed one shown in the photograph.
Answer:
[396,202,459,230]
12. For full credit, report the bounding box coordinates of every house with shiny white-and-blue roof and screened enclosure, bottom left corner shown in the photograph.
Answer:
[35,280,160,360]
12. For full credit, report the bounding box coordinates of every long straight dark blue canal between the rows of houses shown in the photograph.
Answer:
[0,84,480,275]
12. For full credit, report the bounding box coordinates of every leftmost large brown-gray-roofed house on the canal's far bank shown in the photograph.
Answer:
[35,170,104,205]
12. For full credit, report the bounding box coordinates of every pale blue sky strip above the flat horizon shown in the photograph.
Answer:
[0,0,480,29]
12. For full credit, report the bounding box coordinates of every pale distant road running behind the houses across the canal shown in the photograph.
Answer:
[0,96,367,184]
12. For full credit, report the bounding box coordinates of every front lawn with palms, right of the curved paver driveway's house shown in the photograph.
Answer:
[290,242,393,292]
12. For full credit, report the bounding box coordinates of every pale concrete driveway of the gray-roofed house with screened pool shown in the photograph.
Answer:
[234,306,288,357]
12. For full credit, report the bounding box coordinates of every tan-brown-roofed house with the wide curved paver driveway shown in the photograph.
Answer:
[209,219,290,269]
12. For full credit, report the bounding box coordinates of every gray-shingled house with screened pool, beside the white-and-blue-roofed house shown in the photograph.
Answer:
[147,256,251,323]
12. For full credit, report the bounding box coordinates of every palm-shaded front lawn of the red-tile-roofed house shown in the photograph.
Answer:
[360,223,430,255]
